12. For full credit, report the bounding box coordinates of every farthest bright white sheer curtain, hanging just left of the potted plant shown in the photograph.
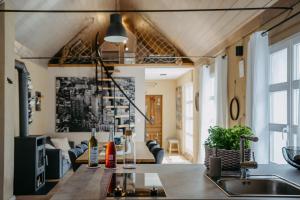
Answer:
[198,65,216,163]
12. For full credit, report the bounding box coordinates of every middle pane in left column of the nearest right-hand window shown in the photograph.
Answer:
[270,91,287,124]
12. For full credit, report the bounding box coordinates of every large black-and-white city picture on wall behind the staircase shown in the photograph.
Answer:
[56,77,135,132]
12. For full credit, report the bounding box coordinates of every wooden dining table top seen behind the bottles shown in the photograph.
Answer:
[76,142,155,164]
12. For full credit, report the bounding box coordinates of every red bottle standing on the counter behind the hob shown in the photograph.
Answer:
[105,132,117,168]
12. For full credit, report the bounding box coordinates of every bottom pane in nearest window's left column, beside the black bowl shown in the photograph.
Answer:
[270,132,287,164]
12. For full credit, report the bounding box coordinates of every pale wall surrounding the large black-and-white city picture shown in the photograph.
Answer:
[45,67,145,143]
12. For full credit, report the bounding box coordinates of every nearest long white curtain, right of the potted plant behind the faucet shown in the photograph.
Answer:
[246,32,269,163]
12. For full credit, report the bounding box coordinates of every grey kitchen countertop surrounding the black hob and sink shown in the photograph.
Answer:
[51,164,300,200]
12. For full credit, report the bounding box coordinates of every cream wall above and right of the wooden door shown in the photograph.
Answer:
[145,80,177,149]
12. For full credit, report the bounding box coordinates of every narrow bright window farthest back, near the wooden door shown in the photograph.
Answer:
[184,83,194,155]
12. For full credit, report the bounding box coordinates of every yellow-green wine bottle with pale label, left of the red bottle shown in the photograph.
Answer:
[88,128,99,167]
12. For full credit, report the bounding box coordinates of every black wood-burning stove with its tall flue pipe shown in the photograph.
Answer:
[14,61,46,195]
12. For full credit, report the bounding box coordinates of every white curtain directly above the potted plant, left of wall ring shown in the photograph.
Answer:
[215,55,228,128]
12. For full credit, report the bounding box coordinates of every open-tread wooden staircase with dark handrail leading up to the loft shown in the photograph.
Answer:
[95,34,151,135]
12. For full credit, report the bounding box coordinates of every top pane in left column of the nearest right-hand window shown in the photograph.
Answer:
[270,49,287,84]
